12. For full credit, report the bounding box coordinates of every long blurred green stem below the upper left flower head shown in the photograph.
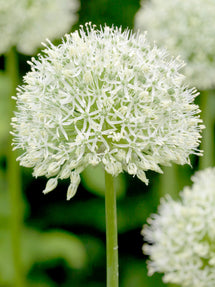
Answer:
[6,49,25,287]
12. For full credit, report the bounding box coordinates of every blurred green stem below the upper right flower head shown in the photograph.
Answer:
[199,91,214,169]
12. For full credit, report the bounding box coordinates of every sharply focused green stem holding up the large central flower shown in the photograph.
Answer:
[105,172,119,287]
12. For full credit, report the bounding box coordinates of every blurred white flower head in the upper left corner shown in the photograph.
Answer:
[0,0,79,55]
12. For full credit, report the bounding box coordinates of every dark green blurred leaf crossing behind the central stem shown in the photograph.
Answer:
[41,191,156,233]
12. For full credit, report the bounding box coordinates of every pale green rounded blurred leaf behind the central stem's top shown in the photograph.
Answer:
[81,165,126,199]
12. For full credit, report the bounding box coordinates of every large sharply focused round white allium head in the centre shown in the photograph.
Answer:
[12,24,202,198]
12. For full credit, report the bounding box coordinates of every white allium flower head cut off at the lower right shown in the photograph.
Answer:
[142,168,215,287]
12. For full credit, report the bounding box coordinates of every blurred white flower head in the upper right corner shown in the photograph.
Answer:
[135,0,215,89]
